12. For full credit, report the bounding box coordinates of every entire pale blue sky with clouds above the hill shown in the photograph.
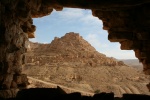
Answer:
[30,8,136,59]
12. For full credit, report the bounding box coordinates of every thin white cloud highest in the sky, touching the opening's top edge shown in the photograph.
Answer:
[55,8,102,25]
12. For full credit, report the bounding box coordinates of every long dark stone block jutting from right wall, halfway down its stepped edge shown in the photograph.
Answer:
[108,31,133,42]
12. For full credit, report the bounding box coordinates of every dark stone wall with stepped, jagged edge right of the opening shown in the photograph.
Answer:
[92,4,150,91]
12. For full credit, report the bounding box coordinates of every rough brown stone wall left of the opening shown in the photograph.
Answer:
[0,0,35,92]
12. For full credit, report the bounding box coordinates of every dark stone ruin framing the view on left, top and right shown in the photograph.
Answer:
[0,0,150,99]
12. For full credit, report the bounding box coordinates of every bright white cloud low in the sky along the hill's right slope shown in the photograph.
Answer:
[85,33,136,59]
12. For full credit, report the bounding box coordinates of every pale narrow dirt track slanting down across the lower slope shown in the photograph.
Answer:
[28,76,94,96]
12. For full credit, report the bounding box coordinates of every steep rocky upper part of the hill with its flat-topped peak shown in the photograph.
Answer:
[27,32,124,66]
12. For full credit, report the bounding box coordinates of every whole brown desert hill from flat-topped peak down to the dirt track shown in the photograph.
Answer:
[23,32,150,96]
